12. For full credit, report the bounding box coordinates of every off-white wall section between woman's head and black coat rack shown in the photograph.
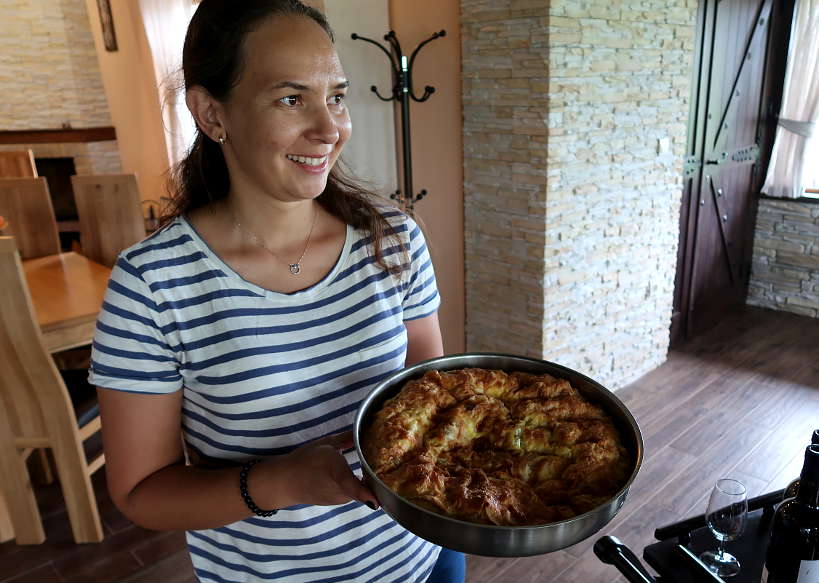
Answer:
[324,0,397,196]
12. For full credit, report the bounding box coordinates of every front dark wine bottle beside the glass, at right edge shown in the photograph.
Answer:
[765,445,819,583]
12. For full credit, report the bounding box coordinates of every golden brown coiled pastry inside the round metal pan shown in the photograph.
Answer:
[362,368,630,526]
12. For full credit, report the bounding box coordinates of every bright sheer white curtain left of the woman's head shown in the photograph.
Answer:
[139,0,196,169]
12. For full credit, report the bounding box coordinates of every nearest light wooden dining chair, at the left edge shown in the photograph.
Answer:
[0,237,105,544]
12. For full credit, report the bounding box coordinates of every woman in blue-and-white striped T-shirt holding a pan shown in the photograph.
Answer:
[91,0,463,582]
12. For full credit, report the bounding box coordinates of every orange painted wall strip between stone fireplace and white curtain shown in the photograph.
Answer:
[85,0,170,200]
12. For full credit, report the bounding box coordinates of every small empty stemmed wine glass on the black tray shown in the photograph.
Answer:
[700,478,748,577]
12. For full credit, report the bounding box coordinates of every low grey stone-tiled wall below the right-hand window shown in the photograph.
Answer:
[748,199,819,318]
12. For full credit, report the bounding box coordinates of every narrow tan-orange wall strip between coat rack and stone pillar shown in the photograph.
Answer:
[390,0,465,353]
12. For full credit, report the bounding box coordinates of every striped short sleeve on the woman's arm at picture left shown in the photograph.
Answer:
[88,256,183,393]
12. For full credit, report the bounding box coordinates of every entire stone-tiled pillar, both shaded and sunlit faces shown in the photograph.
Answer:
[461,0,696,389]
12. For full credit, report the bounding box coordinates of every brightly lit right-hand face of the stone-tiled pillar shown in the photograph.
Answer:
[543,0,697,388]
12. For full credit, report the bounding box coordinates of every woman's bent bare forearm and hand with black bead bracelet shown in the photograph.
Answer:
[97,389,378,530]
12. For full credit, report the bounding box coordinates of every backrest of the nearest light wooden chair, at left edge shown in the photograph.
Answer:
[0,237,74,448]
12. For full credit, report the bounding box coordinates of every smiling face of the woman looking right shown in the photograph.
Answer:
[223,17,351,202]
